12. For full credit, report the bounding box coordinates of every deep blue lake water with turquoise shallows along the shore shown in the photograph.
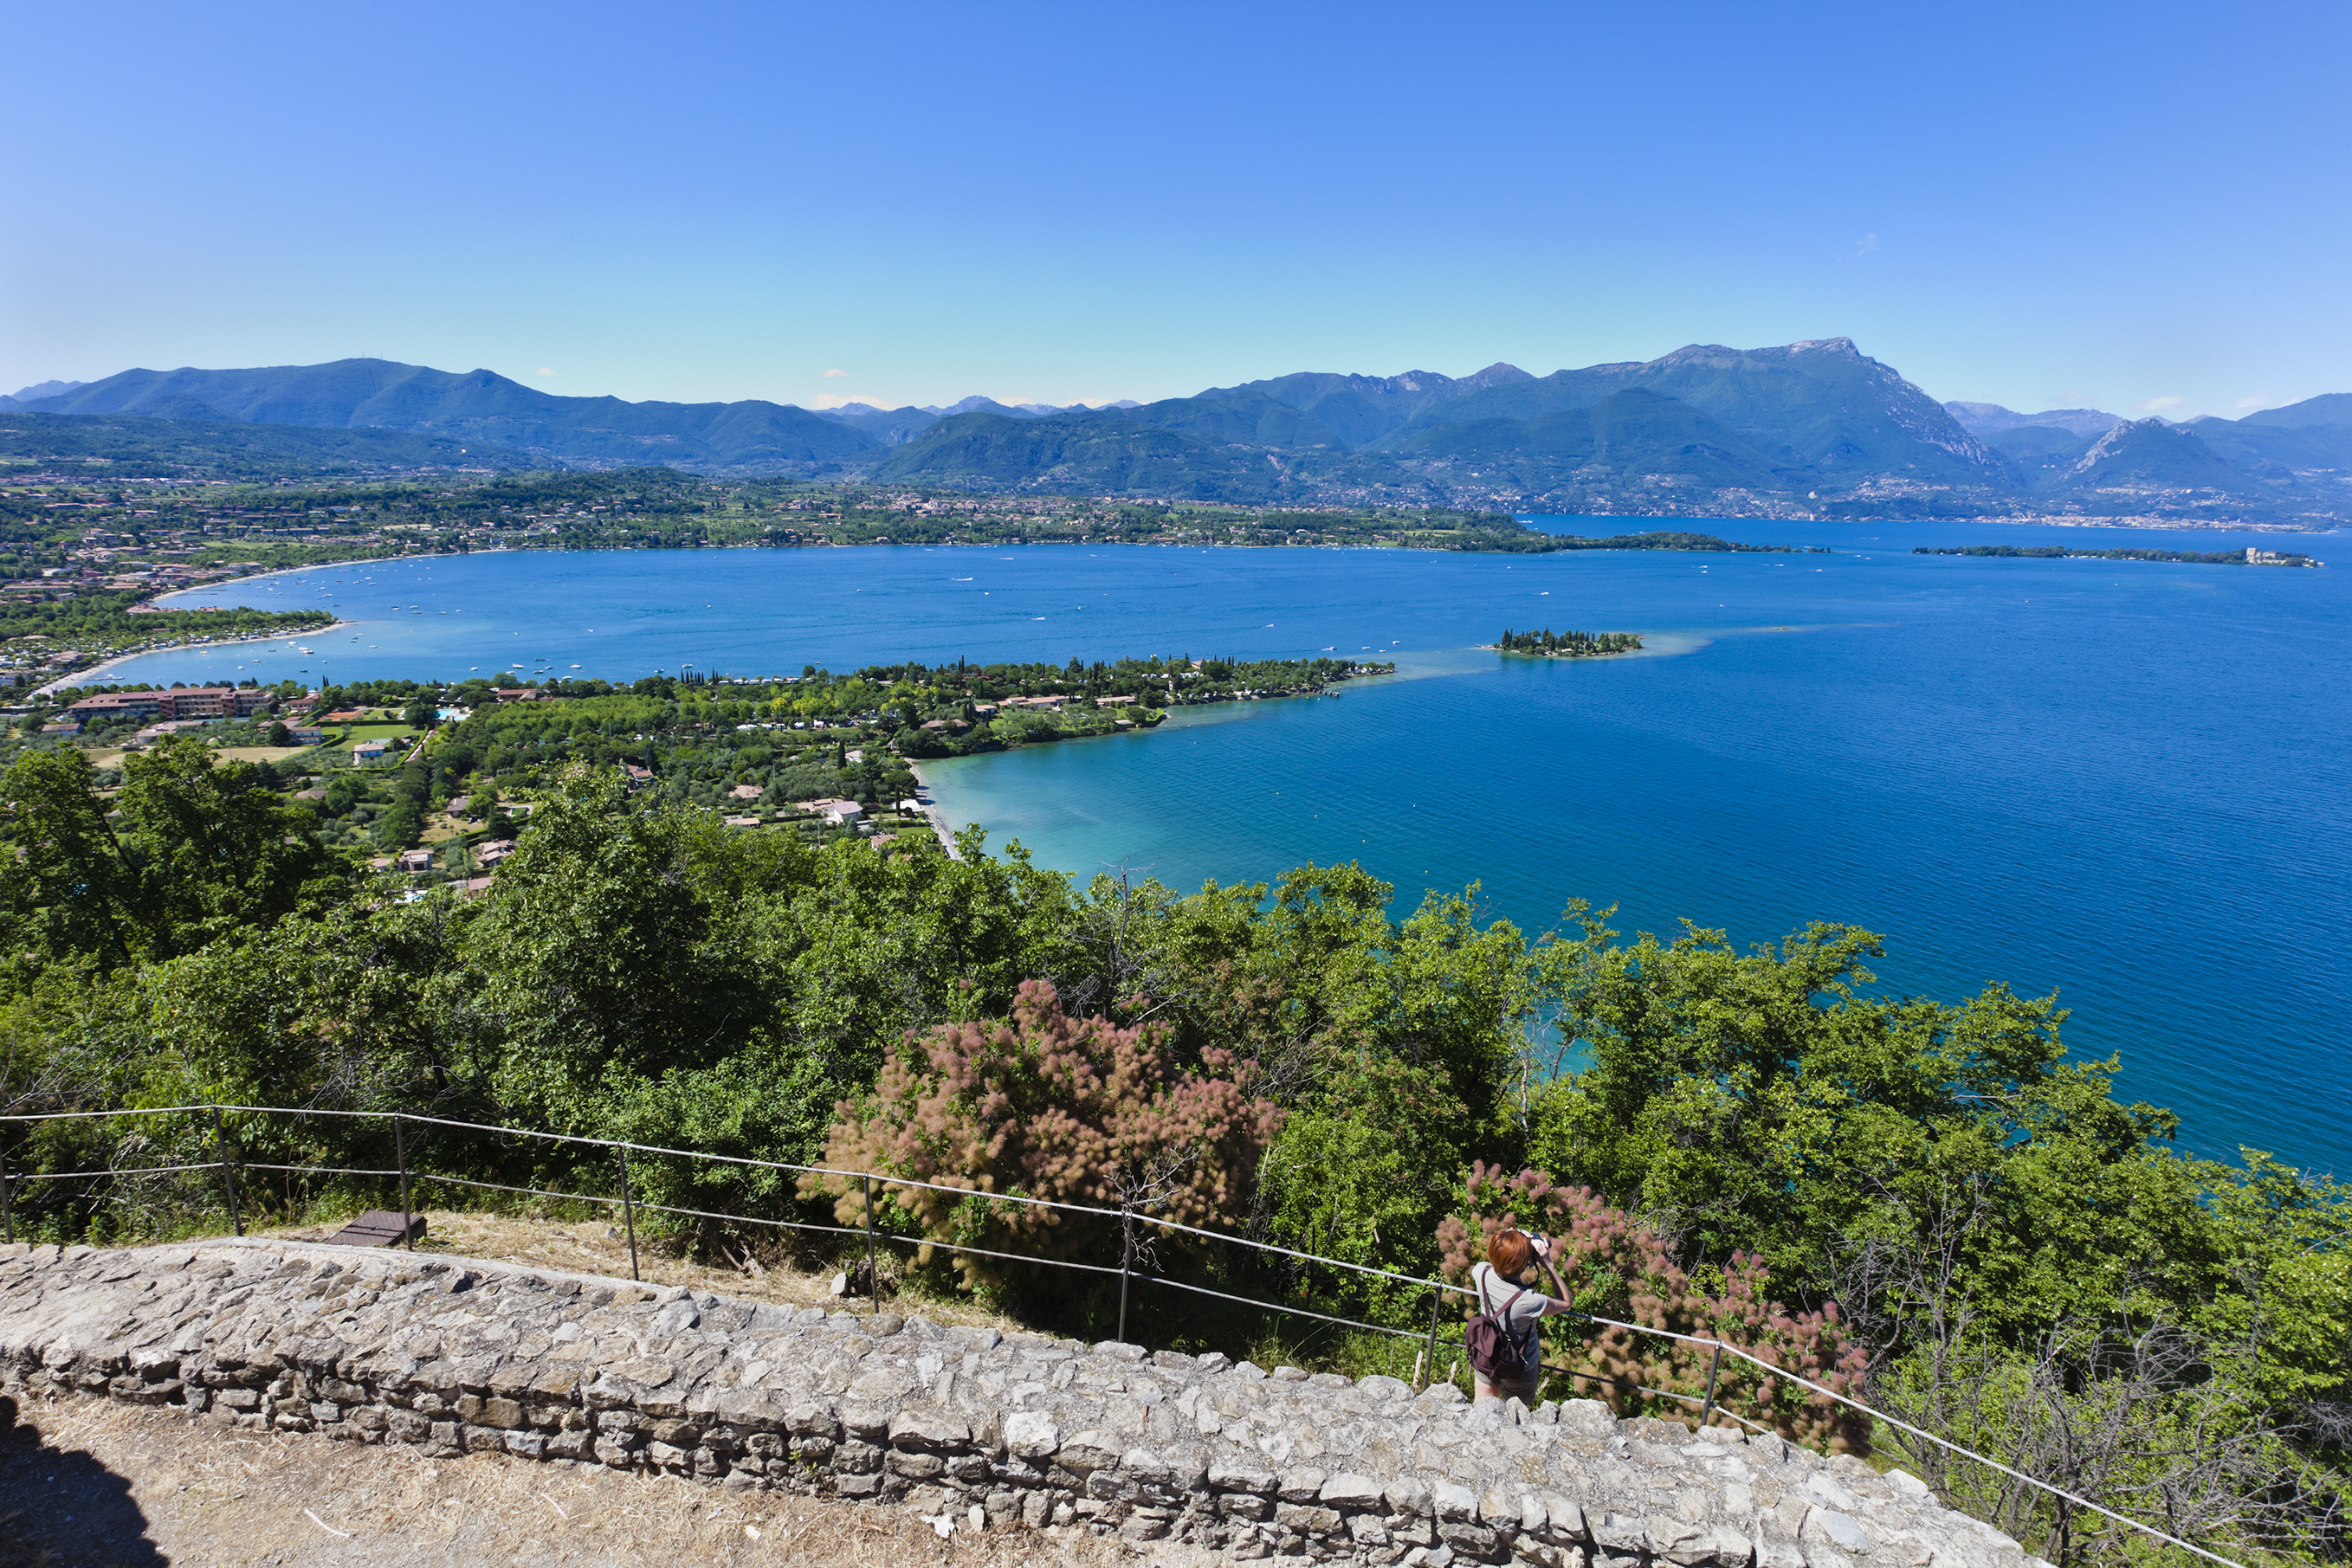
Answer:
[128,522,2352,1168]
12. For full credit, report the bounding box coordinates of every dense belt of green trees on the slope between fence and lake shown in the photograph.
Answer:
[0,731,2352,1561]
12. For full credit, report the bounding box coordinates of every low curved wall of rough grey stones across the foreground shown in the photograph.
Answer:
[0,1242,2046,1568]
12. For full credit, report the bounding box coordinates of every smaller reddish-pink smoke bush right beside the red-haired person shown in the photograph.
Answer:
[1437,1161,1870,1453]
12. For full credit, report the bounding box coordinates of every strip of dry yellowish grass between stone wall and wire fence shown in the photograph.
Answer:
[252,1210,1021,1332]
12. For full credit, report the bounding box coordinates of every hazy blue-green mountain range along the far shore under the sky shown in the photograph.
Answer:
[0,339,2352,526]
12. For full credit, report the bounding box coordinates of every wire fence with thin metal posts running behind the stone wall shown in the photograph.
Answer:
[0,1105,2241,1568]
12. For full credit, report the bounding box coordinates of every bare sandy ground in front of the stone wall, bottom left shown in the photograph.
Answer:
[0,1401,1212,1568]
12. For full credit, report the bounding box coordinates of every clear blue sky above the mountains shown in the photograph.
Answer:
[0,0,2352,418]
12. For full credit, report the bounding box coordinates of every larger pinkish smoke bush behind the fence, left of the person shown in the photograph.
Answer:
[802,980,1282,1286]
